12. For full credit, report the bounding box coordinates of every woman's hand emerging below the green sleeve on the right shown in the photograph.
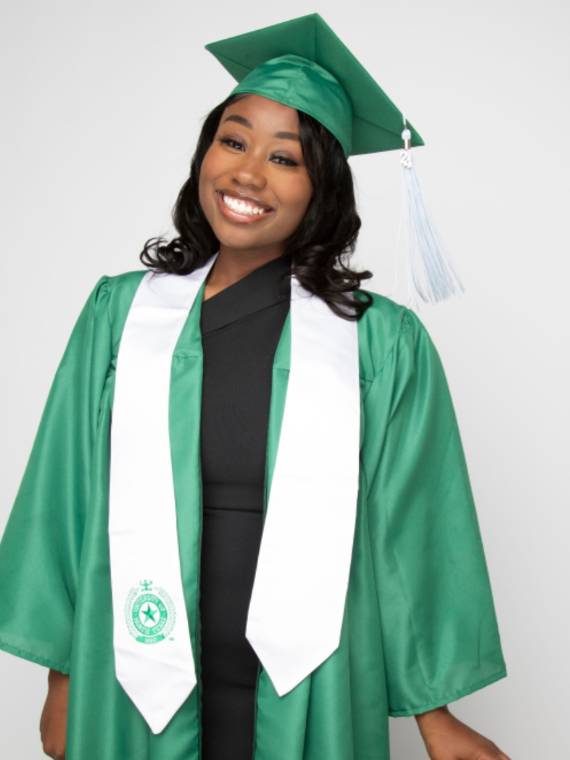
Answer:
[414,706,511,760]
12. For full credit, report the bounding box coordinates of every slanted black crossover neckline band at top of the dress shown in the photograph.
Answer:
[200,253,292,333]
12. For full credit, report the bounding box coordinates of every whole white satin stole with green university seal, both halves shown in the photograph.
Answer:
[109,253,360,734]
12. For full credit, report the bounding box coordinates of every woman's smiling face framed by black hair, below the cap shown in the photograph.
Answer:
[195,94,313,255]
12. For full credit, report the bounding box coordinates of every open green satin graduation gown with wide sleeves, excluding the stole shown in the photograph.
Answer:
[0,270,507,760]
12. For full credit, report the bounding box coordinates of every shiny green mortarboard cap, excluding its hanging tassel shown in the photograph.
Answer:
[205,13,424,157]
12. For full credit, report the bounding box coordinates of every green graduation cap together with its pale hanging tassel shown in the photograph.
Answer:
[205,13,463,302]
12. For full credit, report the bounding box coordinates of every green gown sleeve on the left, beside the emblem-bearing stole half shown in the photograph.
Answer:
[0,276,111,673]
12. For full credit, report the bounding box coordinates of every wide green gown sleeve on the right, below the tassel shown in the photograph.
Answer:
[367,307,507,717]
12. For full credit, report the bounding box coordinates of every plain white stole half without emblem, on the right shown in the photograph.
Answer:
[245,276,360,696]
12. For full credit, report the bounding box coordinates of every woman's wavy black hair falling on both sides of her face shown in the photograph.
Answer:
[140,93,373,320]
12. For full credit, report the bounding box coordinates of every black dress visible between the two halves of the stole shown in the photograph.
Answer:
[200,255,291,760]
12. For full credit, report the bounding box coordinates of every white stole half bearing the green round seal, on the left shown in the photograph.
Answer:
[109,260,217,734]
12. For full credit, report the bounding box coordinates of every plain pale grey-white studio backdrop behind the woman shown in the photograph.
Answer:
[0,0,570,760]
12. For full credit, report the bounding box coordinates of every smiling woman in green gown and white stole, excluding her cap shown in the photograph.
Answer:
[0,14,508,760]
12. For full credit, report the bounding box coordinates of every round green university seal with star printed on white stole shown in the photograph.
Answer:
[125,580,176,644]
